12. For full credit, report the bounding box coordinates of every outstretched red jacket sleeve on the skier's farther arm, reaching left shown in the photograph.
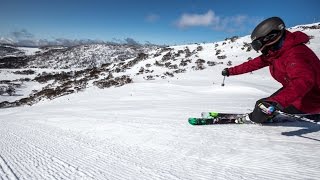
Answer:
[228,56,269,75]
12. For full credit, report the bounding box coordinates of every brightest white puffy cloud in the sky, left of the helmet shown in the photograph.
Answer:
[176,10,219,28]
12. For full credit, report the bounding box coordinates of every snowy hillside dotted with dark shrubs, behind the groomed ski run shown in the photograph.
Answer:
[0,24,320,107]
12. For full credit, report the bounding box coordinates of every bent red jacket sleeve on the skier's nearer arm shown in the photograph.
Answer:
[268,54,315,108]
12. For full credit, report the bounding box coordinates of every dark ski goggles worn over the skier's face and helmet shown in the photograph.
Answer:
[251,31,281,51]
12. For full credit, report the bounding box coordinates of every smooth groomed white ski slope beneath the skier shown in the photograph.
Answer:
[0,23,320,180]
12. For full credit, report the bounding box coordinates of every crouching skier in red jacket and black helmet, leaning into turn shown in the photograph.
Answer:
[222,17,320,123]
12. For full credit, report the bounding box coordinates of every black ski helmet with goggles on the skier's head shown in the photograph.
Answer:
[251,17,285,51]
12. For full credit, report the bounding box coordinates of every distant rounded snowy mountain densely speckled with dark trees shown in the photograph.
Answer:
[27,44,157,69]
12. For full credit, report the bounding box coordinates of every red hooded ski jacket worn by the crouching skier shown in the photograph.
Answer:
[229,31,320,113]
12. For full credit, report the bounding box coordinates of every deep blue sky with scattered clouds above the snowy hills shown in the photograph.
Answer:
[0,0,320,45]
